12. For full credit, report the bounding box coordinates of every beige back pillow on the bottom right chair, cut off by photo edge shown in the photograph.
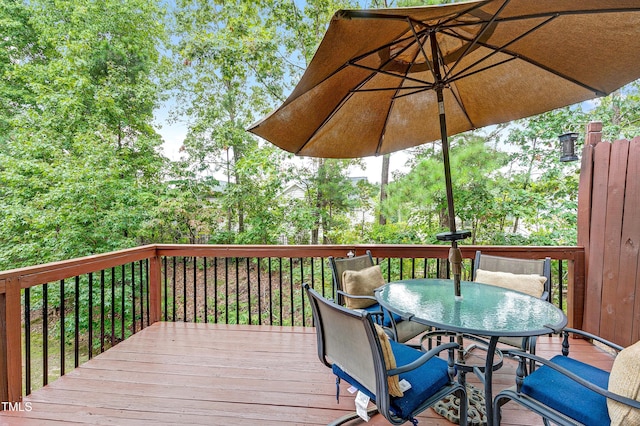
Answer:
[607,341,640,426]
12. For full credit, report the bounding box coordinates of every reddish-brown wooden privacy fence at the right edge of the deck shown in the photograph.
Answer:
[578,123,640,346]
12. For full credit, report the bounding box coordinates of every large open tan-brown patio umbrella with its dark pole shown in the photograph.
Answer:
[249,0,640,296]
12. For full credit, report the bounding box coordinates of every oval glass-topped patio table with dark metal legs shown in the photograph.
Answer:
[375,278,567,425]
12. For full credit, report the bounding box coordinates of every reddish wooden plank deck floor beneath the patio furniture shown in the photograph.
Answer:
[0,322,612,426]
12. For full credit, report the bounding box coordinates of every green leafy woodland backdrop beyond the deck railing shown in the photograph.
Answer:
[0,0,640,269]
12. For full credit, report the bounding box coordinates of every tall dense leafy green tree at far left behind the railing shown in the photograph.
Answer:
[0,0,164,268]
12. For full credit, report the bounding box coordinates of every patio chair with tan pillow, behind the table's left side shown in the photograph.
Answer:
[329,250,429,343]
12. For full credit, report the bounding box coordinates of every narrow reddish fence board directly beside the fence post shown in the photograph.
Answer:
[583,143,611,334]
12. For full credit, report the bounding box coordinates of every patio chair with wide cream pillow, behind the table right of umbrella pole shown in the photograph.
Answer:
[466,250,551,370]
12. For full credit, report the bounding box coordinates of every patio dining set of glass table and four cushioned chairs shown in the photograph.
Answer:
[304,252,640,425]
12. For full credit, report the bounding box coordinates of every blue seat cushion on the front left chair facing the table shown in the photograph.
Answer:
[333,340,449,419]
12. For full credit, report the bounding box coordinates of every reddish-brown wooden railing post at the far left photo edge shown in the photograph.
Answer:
[0,278,22,404]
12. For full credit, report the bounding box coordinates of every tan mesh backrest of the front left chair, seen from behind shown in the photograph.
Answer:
[304,284,389,395]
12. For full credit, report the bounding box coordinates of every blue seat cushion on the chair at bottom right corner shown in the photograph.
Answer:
[521,355,611,425]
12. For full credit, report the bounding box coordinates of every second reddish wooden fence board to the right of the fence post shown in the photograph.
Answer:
[600,140,629,339]
